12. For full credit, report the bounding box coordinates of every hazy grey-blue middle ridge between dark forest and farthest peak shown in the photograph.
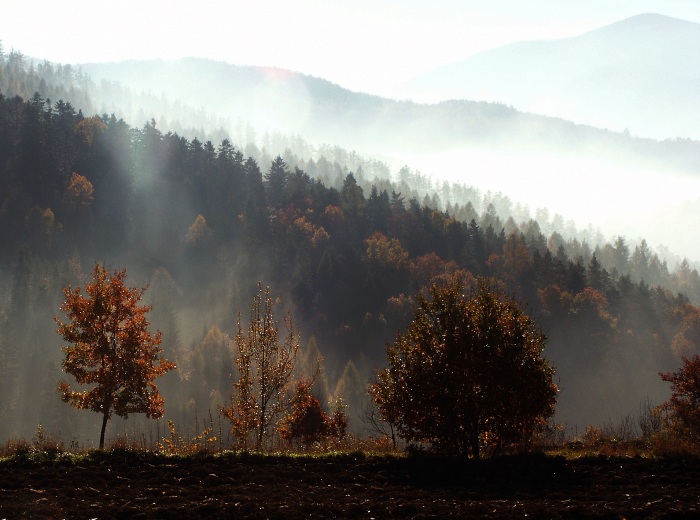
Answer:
[81,54,700,171]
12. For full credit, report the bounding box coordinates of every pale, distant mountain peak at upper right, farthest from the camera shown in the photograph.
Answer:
[400,14,700,139]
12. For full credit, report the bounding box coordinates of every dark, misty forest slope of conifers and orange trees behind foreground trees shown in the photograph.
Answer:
[0,43,700,439]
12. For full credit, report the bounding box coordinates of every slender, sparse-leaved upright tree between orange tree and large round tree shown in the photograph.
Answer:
[221,284,299,451]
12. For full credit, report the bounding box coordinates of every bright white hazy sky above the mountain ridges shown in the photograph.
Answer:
[0,0,700,93]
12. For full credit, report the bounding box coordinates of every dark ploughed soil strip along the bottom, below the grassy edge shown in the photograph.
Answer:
[0,452,700,519]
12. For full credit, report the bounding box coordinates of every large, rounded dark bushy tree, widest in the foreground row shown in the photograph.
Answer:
[370,276,557,458]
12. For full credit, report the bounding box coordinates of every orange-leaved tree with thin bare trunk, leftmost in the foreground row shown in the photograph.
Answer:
[55,264,175,449]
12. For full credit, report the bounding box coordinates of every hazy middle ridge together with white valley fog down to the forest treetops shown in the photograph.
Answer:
[76,54,700,258]
